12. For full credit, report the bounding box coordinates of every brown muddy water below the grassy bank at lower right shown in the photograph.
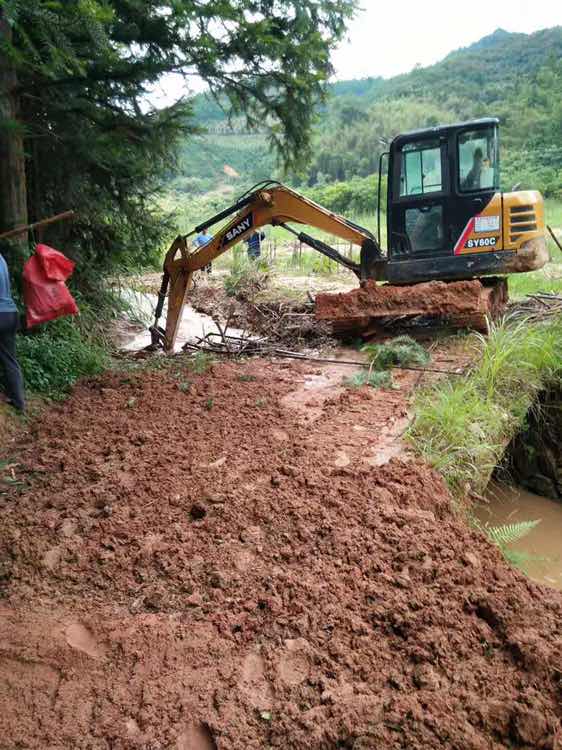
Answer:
[476,484,562,590]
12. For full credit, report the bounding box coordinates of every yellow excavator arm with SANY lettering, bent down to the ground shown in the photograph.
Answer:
[150,183,386,351]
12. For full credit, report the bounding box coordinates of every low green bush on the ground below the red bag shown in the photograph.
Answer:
[17,318,109,399]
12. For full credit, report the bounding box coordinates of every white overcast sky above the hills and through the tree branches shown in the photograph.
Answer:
[148,0,562,106]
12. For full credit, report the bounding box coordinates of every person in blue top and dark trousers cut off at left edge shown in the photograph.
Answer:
[0,255,25,411]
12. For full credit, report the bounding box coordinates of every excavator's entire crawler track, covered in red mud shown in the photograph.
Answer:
[316,278,508,334]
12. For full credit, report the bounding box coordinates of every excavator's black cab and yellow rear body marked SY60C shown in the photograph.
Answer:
[379,117,546,284]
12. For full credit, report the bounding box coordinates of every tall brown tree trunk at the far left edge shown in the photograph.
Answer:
[0,8,28,262]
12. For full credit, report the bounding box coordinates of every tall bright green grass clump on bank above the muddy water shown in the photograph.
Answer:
[408,318,562,497]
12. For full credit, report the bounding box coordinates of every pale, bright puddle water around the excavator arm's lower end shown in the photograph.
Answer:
[116,289,243,352]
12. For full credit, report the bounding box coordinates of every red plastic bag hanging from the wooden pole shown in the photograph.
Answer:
[23,245,78,328]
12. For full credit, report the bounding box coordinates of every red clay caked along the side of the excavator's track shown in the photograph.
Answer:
[316,280,498,321]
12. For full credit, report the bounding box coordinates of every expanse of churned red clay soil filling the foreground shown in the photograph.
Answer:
[0,359,562,750]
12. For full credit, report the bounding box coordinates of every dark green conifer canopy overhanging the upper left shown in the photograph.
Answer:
[0,0,355,274]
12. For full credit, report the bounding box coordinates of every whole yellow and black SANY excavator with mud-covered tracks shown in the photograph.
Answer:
[150,118,548,351]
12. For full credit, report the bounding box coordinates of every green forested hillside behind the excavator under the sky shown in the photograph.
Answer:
[173,27,562,210]
